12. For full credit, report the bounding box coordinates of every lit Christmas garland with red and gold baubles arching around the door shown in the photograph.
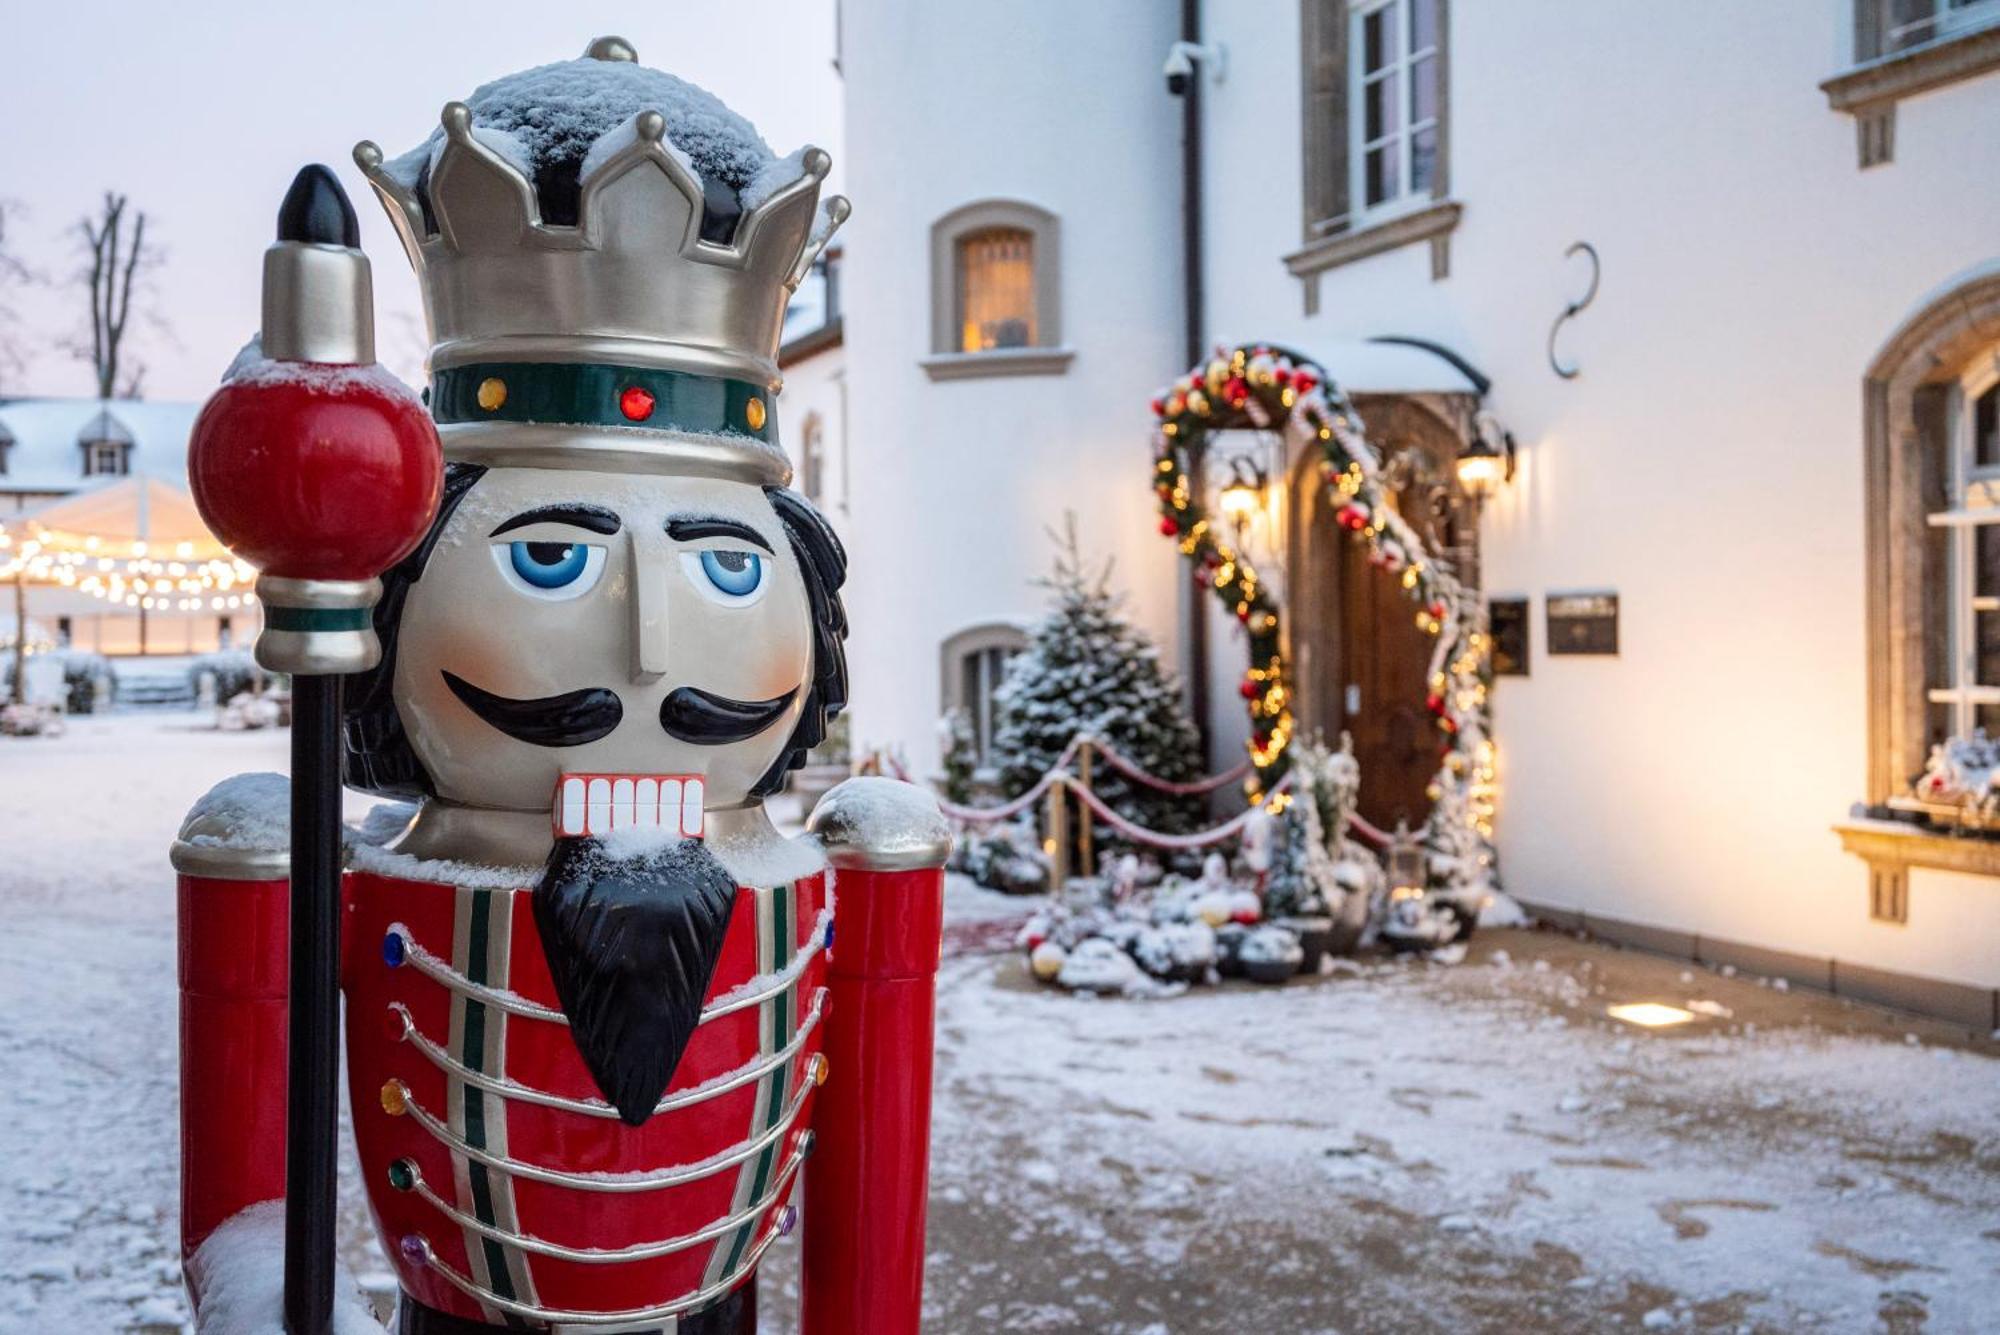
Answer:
[1152,344,1494,859]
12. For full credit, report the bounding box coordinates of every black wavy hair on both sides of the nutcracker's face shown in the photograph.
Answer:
[340,464,848,797]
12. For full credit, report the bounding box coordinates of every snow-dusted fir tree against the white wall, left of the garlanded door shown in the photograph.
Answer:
[992,516,1200,831]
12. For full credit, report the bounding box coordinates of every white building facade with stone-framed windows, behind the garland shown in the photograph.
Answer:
[816,0,2000,1027]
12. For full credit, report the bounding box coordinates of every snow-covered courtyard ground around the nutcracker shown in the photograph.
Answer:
[0,715,2000,1335]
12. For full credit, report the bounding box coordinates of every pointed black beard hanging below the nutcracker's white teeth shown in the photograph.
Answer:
[534,839,736,1127]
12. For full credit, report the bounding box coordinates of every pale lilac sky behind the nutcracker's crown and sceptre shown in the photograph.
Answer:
[0,0,842,400]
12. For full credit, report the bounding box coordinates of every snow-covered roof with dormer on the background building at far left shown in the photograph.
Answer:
[0,398,200,494]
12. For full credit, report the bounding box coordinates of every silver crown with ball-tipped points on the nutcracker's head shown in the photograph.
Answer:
[354,57,848,390]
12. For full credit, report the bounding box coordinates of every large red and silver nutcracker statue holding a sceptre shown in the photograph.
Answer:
[174,38,948,1335]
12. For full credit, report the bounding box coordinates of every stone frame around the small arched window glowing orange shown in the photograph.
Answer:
[922,198,1076,380]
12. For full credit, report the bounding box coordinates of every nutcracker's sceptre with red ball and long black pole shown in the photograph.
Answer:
[188,166,444,1335]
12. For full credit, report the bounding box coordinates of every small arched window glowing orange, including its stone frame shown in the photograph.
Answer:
[924,200,1072,380]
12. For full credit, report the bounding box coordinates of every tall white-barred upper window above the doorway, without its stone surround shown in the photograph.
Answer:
[1348,0,1442,214]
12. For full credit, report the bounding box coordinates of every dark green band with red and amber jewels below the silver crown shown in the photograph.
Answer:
[430,362,778,444]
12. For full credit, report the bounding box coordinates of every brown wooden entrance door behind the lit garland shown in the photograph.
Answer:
[1288,396,1478,829]
